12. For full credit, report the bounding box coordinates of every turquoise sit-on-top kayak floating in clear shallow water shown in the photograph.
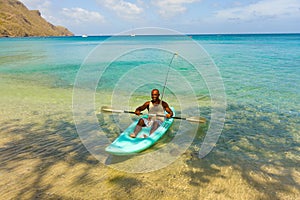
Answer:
[105,107,175,155]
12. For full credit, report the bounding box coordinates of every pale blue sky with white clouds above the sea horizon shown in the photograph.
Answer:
[20,0,300,35]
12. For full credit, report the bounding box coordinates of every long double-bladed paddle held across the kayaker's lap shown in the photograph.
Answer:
[101,106,206,123]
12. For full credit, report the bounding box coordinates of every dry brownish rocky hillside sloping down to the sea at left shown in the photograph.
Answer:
[0,0,73,37]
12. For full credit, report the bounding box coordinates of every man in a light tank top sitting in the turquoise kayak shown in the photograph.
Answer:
[130,89,173,138]
